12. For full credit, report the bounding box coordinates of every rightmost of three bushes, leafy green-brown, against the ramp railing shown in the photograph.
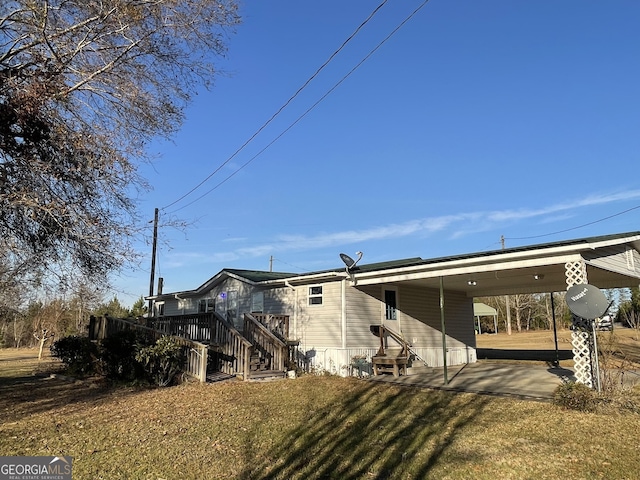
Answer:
[136,337,185,387]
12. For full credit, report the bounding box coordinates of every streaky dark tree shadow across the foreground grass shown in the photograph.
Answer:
[242,384,489,479]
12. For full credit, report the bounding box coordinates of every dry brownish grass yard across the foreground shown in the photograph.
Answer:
[0,350,640,480]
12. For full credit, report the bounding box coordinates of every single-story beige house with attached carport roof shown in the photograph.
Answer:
[148,232,640,374]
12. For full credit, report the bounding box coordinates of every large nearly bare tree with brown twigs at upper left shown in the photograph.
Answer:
[0,0,239,284]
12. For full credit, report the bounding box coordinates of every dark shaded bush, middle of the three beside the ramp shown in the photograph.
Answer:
[100,330,146,381]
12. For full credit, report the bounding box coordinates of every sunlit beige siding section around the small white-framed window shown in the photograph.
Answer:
[296,281,342,350]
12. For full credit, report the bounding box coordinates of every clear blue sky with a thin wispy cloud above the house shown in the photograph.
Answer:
[114,0,640,303]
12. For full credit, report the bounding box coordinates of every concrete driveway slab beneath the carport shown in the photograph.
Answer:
[369,361,575,401]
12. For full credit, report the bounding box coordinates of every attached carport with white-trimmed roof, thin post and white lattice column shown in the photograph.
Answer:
[352,232,640,386]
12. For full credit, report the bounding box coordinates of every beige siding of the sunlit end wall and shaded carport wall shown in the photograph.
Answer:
[300,282,476,375]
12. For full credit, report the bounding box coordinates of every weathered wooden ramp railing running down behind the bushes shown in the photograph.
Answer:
[89,317,208,382]
